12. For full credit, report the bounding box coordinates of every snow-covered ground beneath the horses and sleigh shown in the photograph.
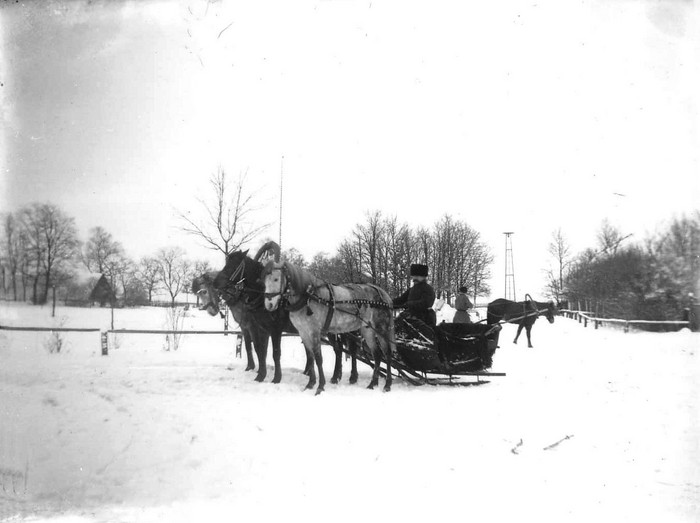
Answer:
[0,302,700,522]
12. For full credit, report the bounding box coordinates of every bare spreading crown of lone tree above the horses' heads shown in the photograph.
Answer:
[178,168,269,256]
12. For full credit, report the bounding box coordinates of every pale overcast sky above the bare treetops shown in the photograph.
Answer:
[0,0,700,297]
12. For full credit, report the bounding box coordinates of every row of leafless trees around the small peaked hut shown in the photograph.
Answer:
[0,203,211,305]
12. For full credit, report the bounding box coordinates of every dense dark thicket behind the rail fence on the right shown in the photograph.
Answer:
[548,211,700,320]
